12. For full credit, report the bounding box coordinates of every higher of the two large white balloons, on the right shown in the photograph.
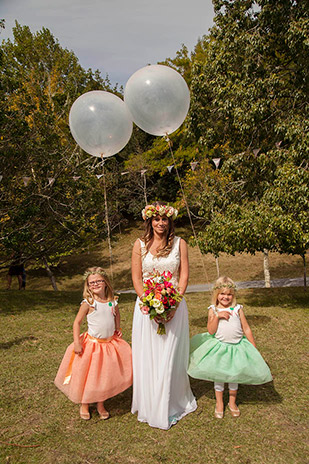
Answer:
[124,64,190,135]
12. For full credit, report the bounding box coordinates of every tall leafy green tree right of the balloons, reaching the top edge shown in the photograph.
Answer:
[180,0,309,284]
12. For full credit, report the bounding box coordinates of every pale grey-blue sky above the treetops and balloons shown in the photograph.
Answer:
[0,0,214,86]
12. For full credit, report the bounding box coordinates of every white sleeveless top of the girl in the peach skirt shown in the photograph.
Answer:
[83,300,117,338]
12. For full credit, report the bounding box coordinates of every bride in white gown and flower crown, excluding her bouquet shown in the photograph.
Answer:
[131,202,196,430]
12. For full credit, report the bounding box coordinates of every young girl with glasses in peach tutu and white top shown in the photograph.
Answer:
[55,267,132,420]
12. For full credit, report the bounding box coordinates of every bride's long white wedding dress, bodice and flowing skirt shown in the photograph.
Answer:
[131,237,197,430]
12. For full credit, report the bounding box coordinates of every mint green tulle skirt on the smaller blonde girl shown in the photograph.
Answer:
[188,332,272,385]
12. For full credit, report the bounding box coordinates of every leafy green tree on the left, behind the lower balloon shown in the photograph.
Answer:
[0,23,121,290]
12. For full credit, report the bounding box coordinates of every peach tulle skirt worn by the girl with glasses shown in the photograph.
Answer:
[55,333,132,403]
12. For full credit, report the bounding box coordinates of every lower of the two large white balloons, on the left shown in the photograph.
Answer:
[69,90,133,158]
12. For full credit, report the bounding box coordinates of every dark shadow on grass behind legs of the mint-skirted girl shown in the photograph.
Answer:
[190,378,282,404]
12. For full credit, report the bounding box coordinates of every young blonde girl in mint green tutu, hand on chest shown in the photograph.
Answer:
[188,277,272,419]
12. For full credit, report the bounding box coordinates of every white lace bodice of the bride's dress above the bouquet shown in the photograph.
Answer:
[140,237,180,285]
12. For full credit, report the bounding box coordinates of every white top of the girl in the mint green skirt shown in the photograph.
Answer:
[208,304,243,343]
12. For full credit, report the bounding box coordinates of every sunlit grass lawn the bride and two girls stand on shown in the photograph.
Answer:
[0,288,308,464]
